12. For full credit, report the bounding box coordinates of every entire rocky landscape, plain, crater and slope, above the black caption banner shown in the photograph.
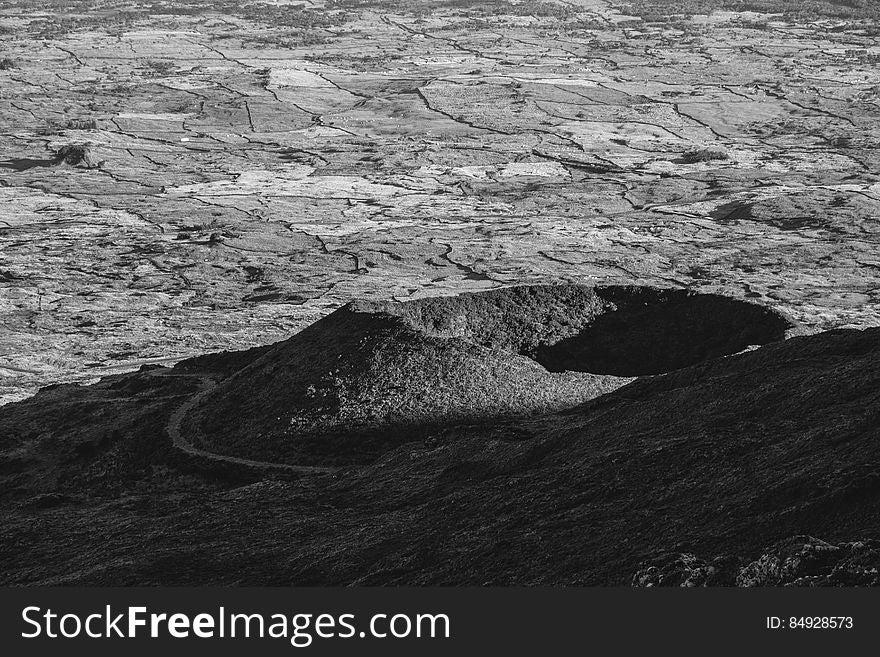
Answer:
[0,0,880,586]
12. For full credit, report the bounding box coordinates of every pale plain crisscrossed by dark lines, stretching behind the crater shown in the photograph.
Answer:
[0,0,880,401]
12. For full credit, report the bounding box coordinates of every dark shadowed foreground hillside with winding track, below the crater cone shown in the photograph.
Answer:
[0,288,880,584]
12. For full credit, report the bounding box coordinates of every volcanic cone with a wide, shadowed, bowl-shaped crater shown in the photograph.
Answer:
[184,285,791,464]
